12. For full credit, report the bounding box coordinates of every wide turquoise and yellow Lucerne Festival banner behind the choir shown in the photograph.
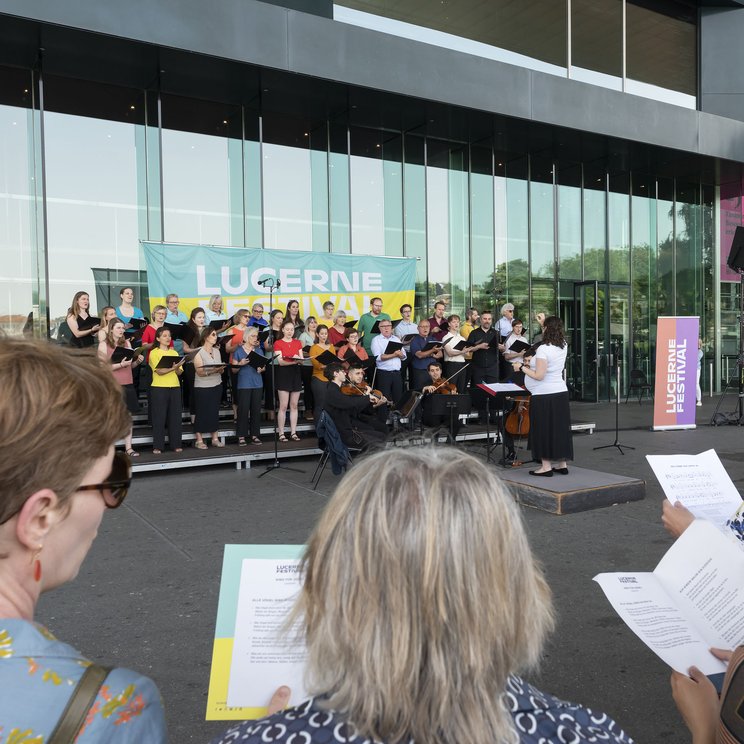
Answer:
[142,241,416,318]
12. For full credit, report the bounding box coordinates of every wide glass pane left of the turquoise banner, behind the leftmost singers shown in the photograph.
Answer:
[44,76,149,324]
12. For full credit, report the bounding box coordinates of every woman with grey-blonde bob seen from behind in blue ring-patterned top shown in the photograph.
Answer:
[213,448,631,744]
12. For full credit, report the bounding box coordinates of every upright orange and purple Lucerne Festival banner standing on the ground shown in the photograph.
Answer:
[653,316,700,431]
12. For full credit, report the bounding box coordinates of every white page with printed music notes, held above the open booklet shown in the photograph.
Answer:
[646,449,742,529]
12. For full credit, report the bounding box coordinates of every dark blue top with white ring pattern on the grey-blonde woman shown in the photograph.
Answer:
[211,676,633,744]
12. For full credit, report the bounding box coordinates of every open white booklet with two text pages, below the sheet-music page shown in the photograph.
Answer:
[594,519,744,675]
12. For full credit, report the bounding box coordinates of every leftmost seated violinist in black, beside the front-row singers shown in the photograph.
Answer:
[325,362,387,449]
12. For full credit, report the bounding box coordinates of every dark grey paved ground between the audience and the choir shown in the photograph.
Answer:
[37,398,744,744]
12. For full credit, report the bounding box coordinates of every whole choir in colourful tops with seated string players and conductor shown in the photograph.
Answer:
[67,287,571,468]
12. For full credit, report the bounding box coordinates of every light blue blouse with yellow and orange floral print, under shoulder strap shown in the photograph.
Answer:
[0,619,168,744]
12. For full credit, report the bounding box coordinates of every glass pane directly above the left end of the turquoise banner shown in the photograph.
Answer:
[160,95,245,245]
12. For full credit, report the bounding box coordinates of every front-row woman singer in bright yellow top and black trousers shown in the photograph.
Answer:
[150,326,186,455]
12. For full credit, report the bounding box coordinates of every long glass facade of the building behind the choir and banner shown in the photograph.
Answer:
[0,0,741,400]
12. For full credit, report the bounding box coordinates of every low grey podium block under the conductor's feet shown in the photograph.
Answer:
[499,463,646,515]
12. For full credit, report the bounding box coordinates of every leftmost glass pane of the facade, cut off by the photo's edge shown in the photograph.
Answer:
[0,68,43,335]
